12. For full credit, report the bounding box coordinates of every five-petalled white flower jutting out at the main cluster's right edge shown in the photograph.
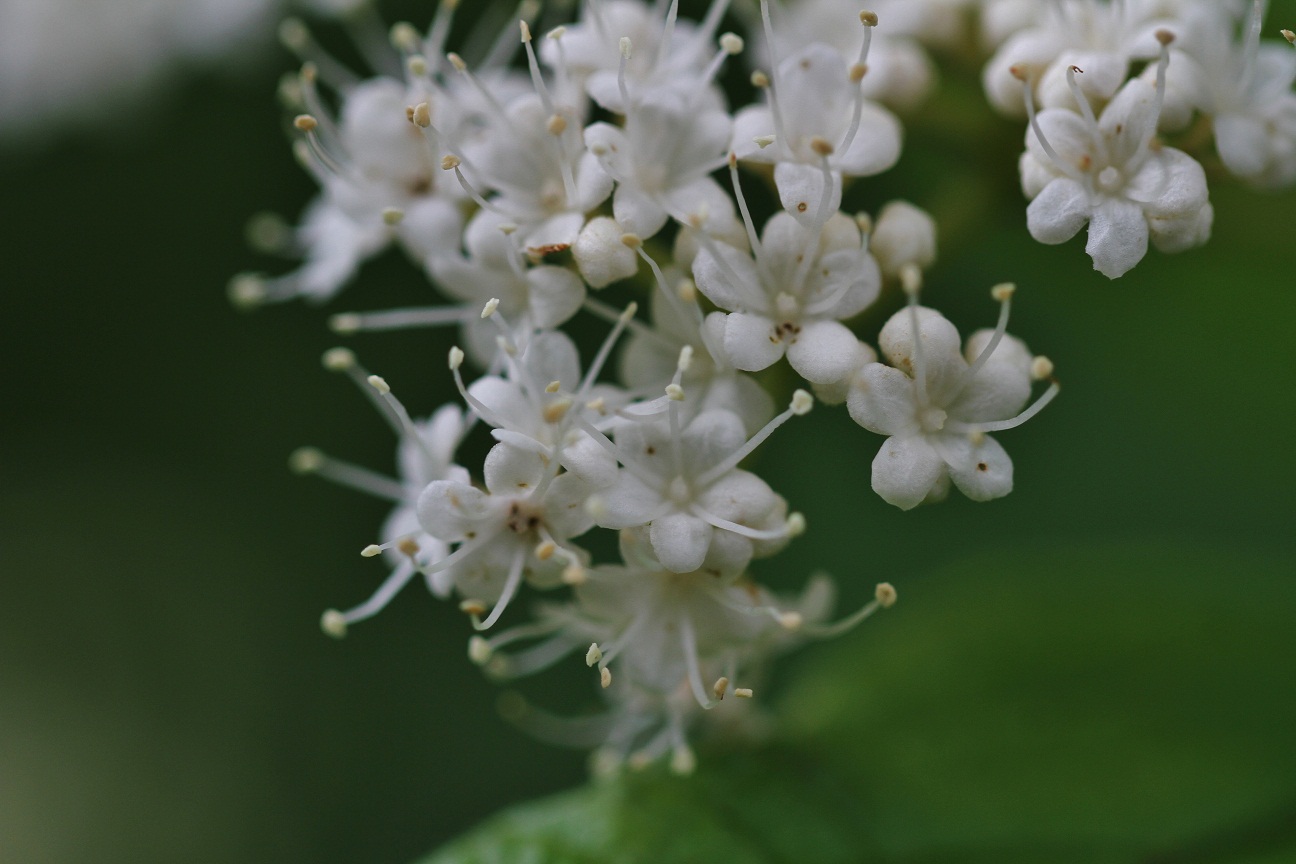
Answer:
[846,286,1058,510]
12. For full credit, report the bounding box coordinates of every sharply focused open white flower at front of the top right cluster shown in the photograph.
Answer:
[1021,58,1213,279]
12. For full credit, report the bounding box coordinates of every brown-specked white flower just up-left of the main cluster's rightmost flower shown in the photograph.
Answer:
[693,212,881,383]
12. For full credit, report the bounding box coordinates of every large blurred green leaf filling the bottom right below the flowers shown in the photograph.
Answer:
[426,545,1296,864]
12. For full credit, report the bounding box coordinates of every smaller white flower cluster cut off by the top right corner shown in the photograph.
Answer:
[982,0,1296,279]
